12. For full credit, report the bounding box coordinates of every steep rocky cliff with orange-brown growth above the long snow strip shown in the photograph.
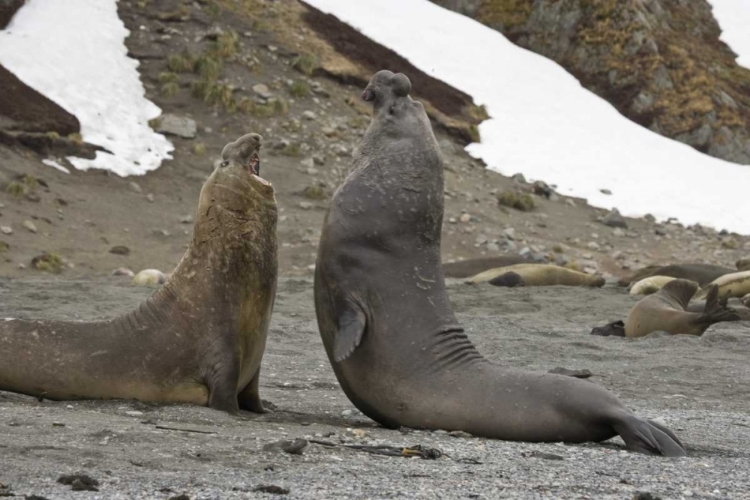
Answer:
[433,0,750,164]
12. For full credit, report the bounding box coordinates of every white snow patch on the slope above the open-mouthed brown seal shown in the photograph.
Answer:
[0,0,174,176]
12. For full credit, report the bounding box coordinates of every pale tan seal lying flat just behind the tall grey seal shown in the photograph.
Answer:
[467,264,604,287]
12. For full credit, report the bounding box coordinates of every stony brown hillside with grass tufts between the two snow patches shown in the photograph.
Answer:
[0,0,750,282]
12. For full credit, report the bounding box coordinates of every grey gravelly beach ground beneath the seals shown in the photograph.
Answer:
[0,279,750,499]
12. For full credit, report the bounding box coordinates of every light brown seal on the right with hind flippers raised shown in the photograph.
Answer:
[625,279,741,338]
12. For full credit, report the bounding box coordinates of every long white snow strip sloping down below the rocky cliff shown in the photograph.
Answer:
[306,0,750,234]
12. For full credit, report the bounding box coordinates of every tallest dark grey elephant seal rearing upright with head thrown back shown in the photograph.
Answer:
[315,71,685,456]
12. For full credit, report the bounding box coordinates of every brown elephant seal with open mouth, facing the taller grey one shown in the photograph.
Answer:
[0,134,277,413]
